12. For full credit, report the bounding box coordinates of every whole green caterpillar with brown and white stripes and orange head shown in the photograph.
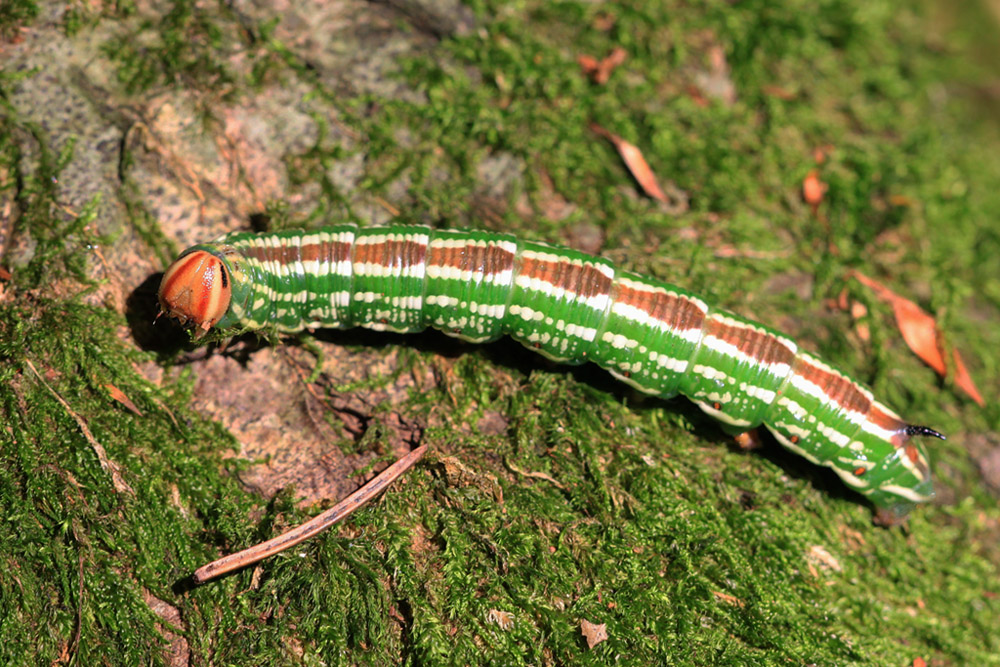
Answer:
[158,224,944,524]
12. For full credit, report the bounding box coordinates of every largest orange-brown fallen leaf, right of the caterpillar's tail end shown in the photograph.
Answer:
[851,271,985,407]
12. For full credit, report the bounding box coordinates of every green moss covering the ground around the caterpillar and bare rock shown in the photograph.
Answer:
[0,0,1000,665]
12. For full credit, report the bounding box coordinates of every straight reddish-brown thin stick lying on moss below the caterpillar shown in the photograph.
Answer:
[192,445,427,584]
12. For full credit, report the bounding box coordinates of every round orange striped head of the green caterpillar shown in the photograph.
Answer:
[158,250,233,337]
